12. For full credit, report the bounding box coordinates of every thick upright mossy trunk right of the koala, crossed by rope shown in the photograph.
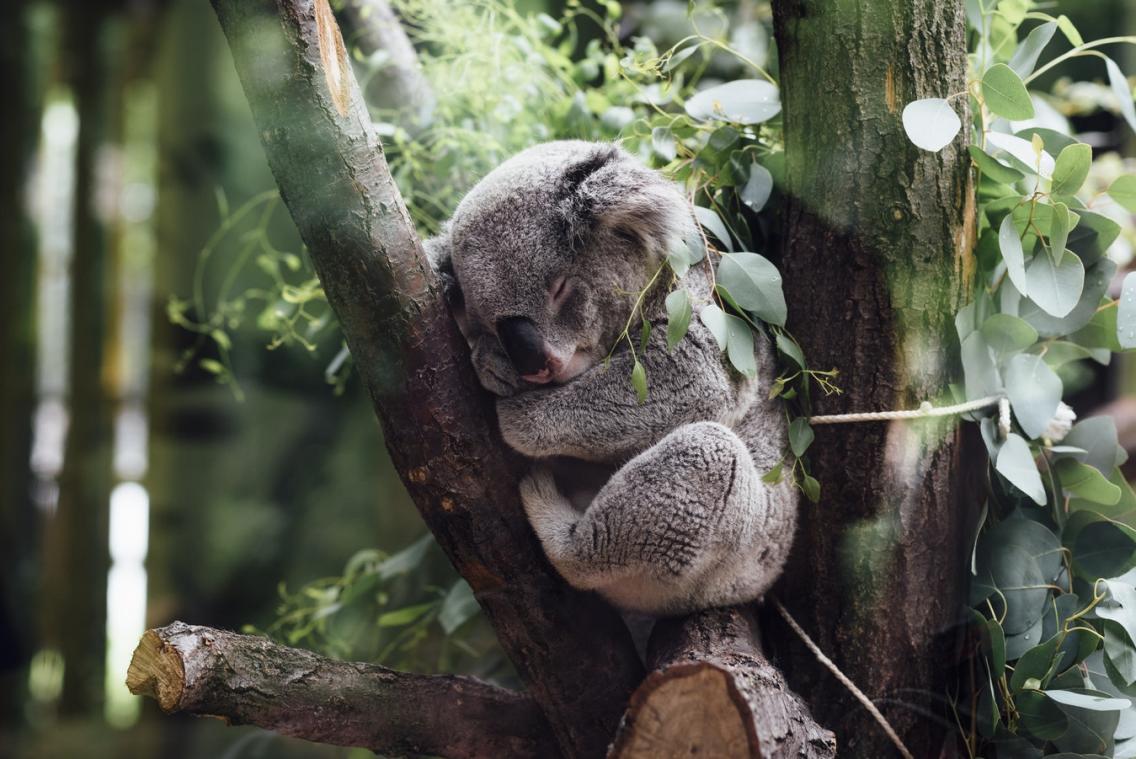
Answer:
[774,0,974,757]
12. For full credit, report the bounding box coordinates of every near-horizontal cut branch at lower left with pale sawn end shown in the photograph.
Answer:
[126,622,557,759]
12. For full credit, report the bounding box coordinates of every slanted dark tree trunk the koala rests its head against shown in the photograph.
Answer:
[212,0,642,757]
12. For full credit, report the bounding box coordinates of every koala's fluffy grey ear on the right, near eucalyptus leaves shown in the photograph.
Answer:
[560,145,693,256]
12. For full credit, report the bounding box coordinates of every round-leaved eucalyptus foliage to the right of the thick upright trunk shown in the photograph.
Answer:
[903,0,1136,757]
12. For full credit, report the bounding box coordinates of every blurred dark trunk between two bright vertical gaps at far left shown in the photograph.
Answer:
[45,2,115,716]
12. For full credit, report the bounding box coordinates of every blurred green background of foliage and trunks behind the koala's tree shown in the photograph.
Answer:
[0,0,1136,759]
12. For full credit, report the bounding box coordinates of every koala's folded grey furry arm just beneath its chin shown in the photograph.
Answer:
[498,317,743,461]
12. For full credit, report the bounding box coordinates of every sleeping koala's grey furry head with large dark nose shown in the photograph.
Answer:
[427,141,693,394]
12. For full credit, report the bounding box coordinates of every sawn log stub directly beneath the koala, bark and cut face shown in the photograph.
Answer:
[610,607,836,759]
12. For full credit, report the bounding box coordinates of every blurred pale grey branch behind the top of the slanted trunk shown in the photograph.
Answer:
[343,0,435,126]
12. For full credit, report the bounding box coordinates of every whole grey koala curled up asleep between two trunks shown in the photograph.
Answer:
[426,141,797,616]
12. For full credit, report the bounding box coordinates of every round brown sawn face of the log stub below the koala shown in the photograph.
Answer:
[610,662,761,759]
